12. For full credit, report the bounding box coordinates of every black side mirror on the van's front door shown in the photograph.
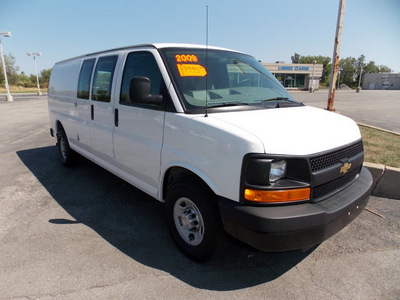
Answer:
[129,76,163,105]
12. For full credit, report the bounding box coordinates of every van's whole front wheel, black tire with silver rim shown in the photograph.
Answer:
[165,179,224,262]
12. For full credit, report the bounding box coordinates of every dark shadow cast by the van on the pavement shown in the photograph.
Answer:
[17,146,313,291]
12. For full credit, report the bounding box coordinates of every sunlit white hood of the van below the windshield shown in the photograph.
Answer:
[209,106,361,155]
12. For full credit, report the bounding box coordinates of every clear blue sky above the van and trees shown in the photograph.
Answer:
[0,0,400,75]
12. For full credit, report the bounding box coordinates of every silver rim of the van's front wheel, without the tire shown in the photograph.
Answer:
[174,197,204,246]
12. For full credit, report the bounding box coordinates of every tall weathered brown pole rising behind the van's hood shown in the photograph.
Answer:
[326,0,346,111]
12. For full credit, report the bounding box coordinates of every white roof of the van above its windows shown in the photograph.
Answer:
[56,43,238,64]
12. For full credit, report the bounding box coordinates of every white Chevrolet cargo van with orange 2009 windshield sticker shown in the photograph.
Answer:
[48,44,372,261]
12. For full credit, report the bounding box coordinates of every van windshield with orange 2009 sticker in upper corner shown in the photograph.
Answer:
[161,48,302,113]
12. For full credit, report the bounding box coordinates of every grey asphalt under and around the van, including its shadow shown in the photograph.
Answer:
[0,97,400,299]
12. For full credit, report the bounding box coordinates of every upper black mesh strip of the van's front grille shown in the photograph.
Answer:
[310,142,364,172]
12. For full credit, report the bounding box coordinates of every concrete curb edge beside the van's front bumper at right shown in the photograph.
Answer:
[364,162,400,200]
